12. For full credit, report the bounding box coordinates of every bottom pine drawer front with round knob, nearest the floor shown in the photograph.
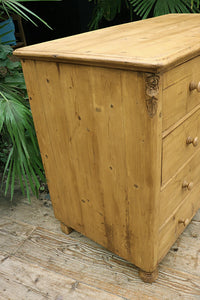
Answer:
[158,186,200,261]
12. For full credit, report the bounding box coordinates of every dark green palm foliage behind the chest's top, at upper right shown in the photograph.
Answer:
[88,0,200,29]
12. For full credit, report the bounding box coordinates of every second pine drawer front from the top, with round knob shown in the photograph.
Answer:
[162,110,200,184]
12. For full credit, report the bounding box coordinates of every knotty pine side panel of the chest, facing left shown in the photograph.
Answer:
[23,60,161,271]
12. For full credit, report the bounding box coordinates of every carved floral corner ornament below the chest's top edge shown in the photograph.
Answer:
[145,73,160,118]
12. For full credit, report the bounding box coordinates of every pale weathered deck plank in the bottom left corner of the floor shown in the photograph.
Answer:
[0,255,124,300]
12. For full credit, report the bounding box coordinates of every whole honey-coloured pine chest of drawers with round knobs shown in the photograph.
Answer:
[15,14,200,282]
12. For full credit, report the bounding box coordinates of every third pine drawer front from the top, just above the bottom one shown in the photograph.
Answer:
[159,150,200,226]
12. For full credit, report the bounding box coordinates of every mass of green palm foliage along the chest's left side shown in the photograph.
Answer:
[0,44,45,199]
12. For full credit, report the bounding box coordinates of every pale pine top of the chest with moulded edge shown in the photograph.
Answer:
[14,14,200,71]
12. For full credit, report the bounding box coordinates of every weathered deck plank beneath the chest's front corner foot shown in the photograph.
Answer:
[12,228,200,300]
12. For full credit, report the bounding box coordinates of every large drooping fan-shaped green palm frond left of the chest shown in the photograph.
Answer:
[0,89,44,199]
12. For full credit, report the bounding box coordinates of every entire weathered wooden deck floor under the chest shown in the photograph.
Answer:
[0,195,200,300]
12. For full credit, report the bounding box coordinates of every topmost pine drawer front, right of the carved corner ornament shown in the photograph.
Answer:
[163,57,200,131]
